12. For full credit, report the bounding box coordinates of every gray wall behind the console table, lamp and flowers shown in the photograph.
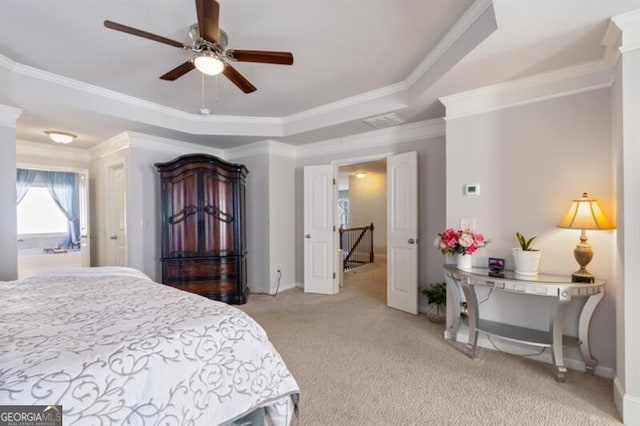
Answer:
[446,89,615,368]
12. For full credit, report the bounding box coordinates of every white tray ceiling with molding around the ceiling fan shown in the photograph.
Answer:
[0,0,640,148]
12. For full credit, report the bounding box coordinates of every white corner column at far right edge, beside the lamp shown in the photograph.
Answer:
[604,10,640,425]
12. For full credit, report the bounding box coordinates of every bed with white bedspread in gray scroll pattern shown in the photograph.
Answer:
[0,267,299,426]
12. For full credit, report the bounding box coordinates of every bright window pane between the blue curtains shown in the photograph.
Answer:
[18,186,68,235]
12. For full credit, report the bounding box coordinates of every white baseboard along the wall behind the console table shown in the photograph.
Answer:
[444,327,615,379]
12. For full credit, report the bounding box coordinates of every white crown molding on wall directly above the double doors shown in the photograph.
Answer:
[296,118,445,158]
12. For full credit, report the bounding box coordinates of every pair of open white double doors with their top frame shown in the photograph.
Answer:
[303,151,418,315]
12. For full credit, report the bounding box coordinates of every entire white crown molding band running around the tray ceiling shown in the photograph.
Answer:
[0,0,493,143]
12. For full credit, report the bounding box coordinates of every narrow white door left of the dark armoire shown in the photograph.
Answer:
[106,163,127,266]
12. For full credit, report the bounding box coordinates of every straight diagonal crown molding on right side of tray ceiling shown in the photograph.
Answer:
[404,0,493,88]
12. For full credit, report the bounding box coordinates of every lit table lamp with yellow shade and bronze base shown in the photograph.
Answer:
[557,192,614,283]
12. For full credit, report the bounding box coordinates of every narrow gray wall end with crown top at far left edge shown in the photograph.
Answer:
[0,105,22,281]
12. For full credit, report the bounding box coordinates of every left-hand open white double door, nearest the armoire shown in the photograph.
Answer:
[304,165,338,294]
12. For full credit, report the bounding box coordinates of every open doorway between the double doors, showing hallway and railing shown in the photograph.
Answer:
[337,158,387,304]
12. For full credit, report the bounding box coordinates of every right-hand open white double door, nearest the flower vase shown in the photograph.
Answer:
[387,151,418,315]
